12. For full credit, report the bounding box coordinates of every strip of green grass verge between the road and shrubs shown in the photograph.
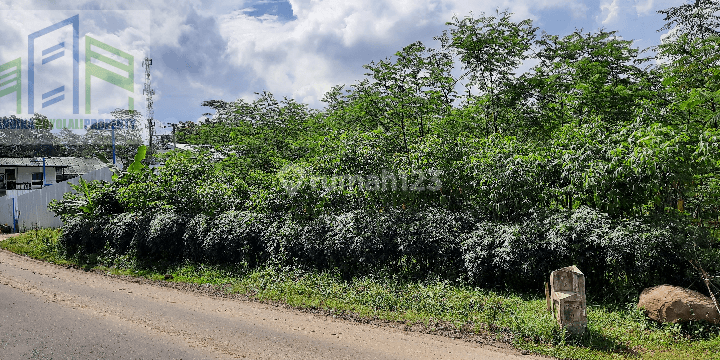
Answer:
[0,230,720,359]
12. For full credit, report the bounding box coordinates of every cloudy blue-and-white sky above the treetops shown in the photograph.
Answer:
[0,0,683,137]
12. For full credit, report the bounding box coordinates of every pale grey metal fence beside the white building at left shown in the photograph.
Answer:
[0,168,112,231]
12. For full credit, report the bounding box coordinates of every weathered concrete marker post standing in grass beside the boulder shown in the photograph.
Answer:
[545,265,587,335]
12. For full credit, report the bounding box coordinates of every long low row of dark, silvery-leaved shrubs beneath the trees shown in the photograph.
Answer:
[61,207,720,300]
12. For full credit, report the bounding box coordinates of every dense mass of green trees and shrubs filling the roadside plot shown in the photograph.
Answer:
[19,0,720,358]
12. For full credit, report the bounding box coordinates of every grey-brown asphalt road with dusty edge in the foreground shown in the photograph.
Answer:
[0,242,540,360]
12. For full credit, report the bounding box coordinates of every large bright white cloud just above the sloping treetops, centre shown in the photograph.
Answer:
[218,0,527,106]
